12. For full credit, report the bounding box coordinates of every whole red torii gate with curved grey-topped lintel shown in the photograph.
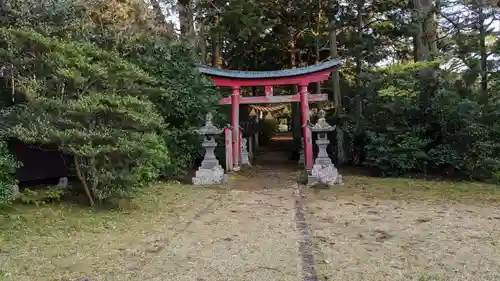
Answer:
[198,60,341,169]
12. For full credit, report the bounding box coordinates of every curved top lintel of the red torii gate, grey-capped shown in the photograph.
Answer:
[198,59,341,87]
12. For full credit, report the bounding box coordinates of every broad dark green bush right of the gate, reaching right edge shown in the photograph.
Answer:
[363,60,500,181]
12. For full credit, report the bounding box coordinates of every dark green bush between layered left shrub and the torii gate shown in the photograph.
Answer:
[129,38,222,177]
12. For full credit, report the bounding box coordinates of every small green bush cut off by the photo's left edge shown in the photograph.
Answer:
[0,141,20,205]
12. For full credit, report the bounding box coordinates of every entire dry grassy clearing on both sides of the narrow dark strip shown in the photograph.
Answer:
[0,173,500,281]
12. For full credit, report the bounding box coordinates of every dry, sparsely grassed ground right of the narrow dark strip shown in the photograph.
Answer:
[308,174,500,281]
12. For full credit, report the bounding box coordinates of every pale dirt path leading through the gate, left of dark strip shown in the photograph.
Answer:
[131,138,302,281]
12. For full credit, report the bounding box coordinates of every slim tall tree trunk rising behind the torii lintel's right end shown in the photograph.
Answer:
[329,1,347,165]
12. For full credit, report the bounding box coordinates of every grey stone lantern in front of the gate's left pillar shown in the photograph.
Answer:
[192,113,227,185]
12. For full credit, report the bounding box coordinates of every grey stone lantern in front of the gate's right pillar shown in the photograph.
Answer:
[308,110,342,186]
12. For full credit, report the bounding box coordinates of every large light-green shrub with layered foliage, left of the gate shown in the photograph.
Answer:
[0,28,169,204]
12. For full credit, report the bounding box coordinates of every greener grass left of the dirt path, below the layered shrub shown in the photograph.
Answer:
[0,185,216,281]
